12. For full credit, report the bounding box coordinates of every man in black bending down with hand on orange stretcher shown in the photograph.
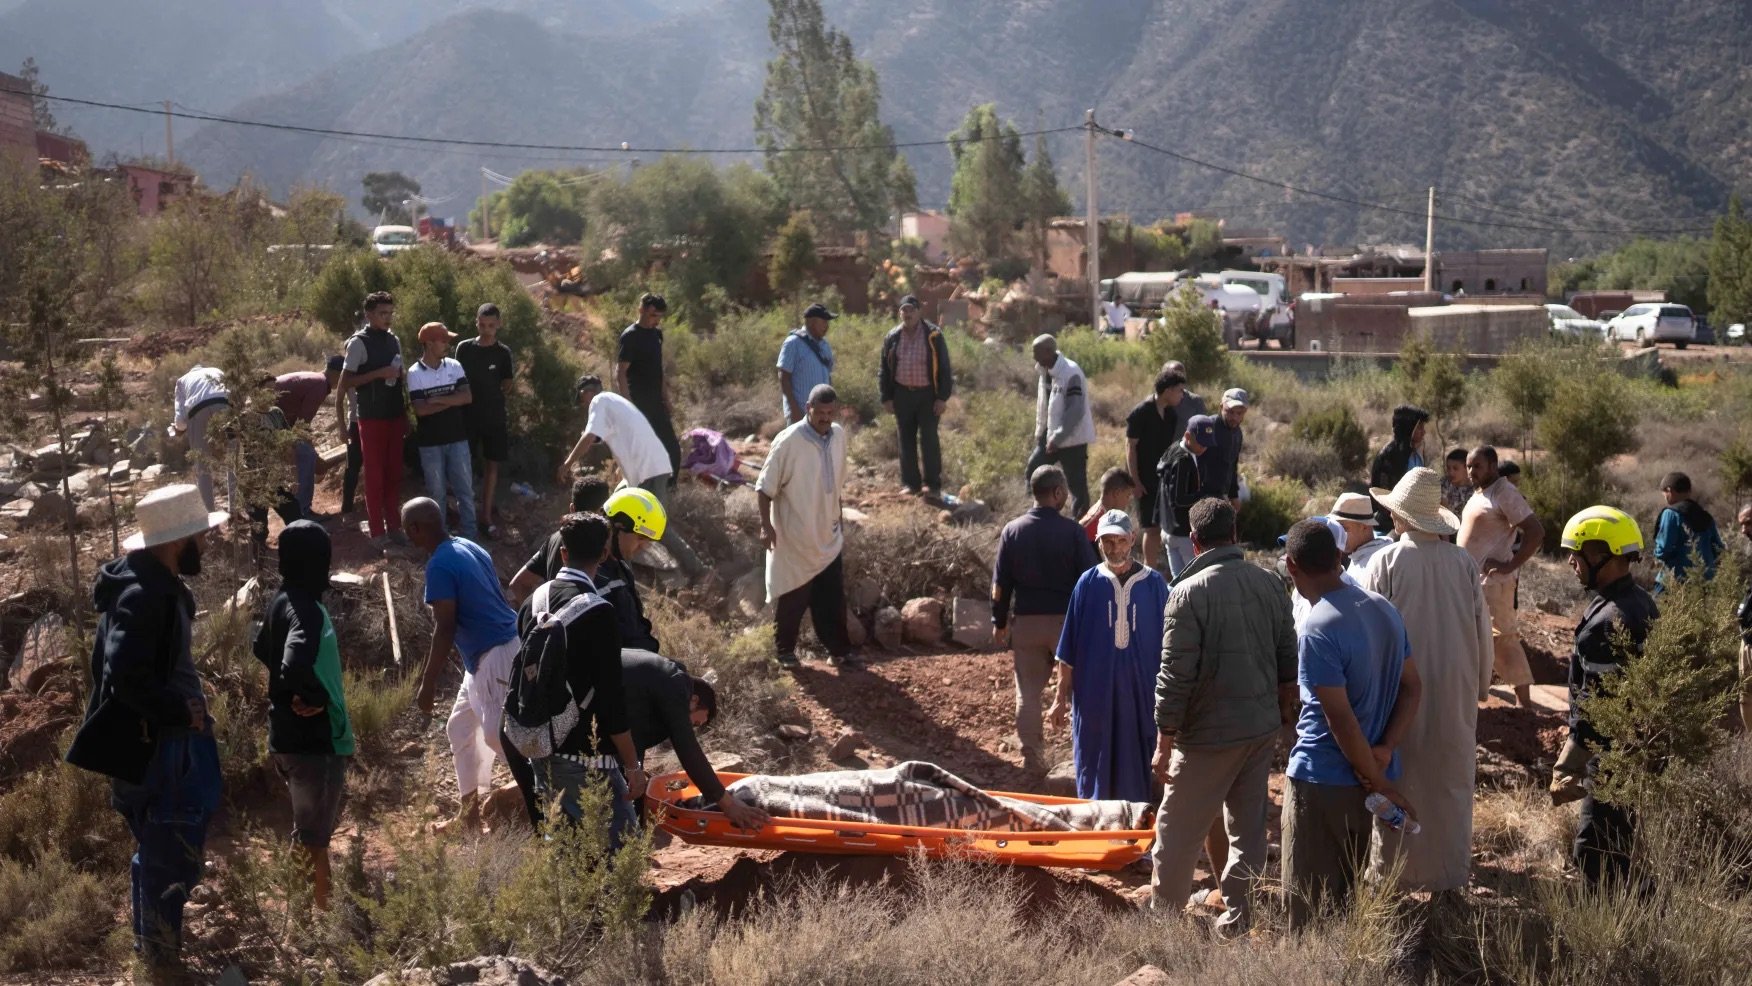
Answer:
[623,648,769,830]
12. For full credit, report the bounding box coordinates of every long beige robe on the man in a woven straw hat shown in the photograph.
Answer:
[1360,531,1493,891]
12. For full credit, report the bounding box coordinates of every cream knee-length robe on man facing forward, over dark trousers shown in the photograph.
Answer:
[755,419,846,602]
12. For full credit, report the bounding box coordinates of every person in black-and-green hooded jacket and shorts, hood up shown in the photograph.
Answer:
[256,520,354,911]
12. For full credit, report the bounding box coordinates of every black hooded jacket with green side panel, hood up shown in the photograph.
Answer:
[256,520,354,757]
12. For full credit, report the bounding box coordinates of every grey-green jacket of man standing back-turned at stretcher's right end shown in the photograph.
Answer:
[1156,545,1296,746]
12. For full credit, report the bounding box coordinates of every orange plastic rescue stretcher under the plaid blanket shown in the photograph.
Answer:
[645,772,1156,870]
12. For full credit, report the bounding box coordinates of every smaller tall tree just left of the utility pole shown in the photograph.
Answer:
[950,103,1028,261]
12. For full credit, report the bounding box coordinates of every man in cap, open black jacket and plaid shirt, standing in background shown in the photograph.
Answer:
[876,294,955,496]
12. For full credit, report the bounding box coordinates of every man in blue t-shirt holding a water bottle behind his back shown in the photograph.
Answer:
[1282,518,1423,930]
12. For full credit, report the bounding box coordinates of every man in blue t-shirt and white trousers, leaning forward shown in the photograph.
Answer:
[401,497,520,830]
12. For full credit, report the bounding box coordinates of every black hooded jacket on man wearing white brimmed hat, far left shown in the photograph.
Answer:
[67,552,203,785]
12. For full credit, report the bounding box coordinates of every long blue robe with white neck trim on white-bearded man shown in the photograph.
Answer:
[1056,562,1169,802]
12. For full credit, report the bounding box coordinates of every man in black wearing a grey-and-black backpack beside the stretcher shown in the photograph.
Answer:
[517,513,645,849]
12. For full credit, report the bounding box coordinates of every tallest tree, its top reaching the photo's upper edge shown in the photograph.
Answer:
[755,0,916,233]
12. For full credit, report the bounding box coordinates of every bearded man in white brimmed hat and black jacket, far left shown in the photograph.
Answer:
[67,485,228,968]
